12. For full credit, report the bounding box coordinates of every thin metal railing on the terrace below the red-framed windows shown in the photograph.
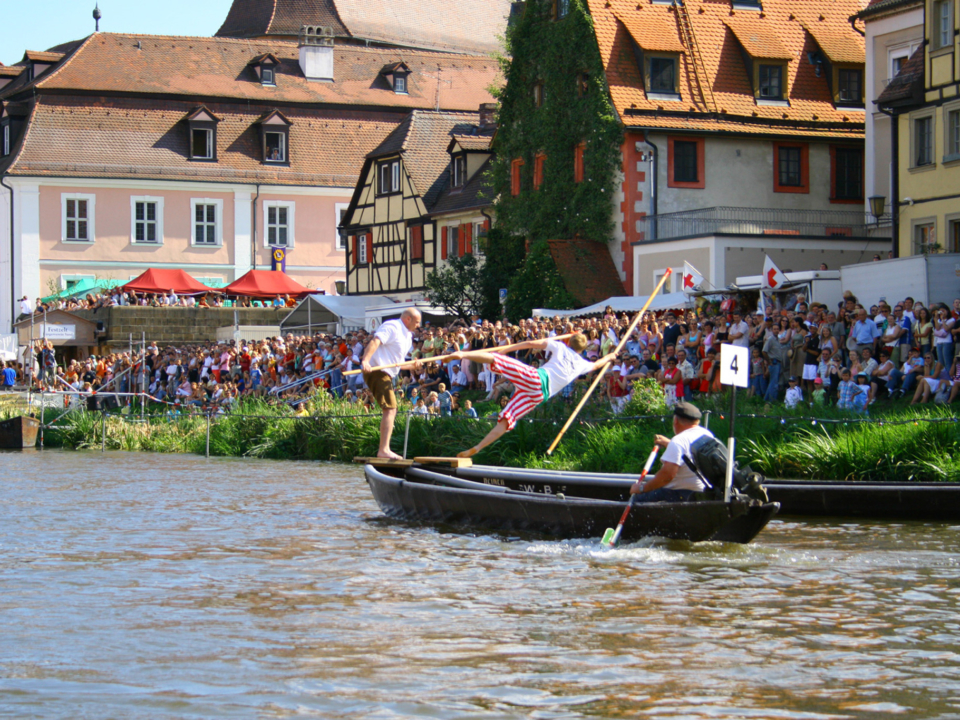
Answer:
[637,207,890,240]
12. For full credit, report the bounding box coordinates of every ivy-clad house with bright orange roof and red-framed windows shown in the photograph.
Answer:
[497,0,889,302]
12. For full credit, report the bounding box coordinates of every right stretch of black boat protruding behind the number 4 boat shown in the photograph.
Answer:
[765,480,960,522]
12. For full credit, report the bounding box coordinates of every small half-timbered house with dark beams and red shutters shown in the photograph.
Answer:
[340,106,494,300]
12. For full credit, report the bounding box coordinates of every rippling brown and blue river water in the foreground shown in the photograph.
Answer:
[0,451,960,720]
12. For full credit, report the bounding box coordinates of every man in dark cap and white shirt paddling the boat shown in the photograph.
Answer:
[630,401,713,503]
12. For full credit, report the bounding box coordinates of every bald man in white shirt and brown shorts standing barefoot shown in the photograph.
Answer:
[360,308,420,460]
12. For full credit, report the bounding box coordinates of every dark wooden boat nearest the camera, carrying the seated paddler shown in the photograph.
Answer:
[364,464,779,543]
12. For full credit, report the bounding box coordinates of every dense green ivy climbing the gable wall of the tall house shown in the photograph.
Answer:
[488,0,623,317]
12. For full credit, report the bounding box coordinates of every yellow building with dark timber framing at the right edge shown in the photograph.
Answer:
[877,0,960,256]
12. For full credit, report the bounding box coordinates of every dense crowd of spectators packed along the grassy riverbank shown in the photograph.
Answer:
[5,294,960,417]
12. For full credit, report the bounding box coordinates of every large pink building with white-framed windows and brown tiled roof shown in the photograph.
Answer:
[0,26,498,330]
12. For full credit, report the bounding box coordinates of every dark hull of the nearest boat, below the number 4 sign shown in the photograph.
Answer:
[364,465,776,542]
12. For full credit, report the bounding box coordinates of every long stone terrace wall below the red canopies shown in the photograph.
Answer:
[72,307,290,348]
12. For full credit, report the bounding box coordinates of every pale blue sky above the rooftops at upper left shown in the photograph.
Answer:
[0,0,230,65]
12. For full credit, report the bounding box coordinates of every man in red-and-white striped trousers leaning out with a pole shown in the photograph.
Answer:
[450,333,616,458]
